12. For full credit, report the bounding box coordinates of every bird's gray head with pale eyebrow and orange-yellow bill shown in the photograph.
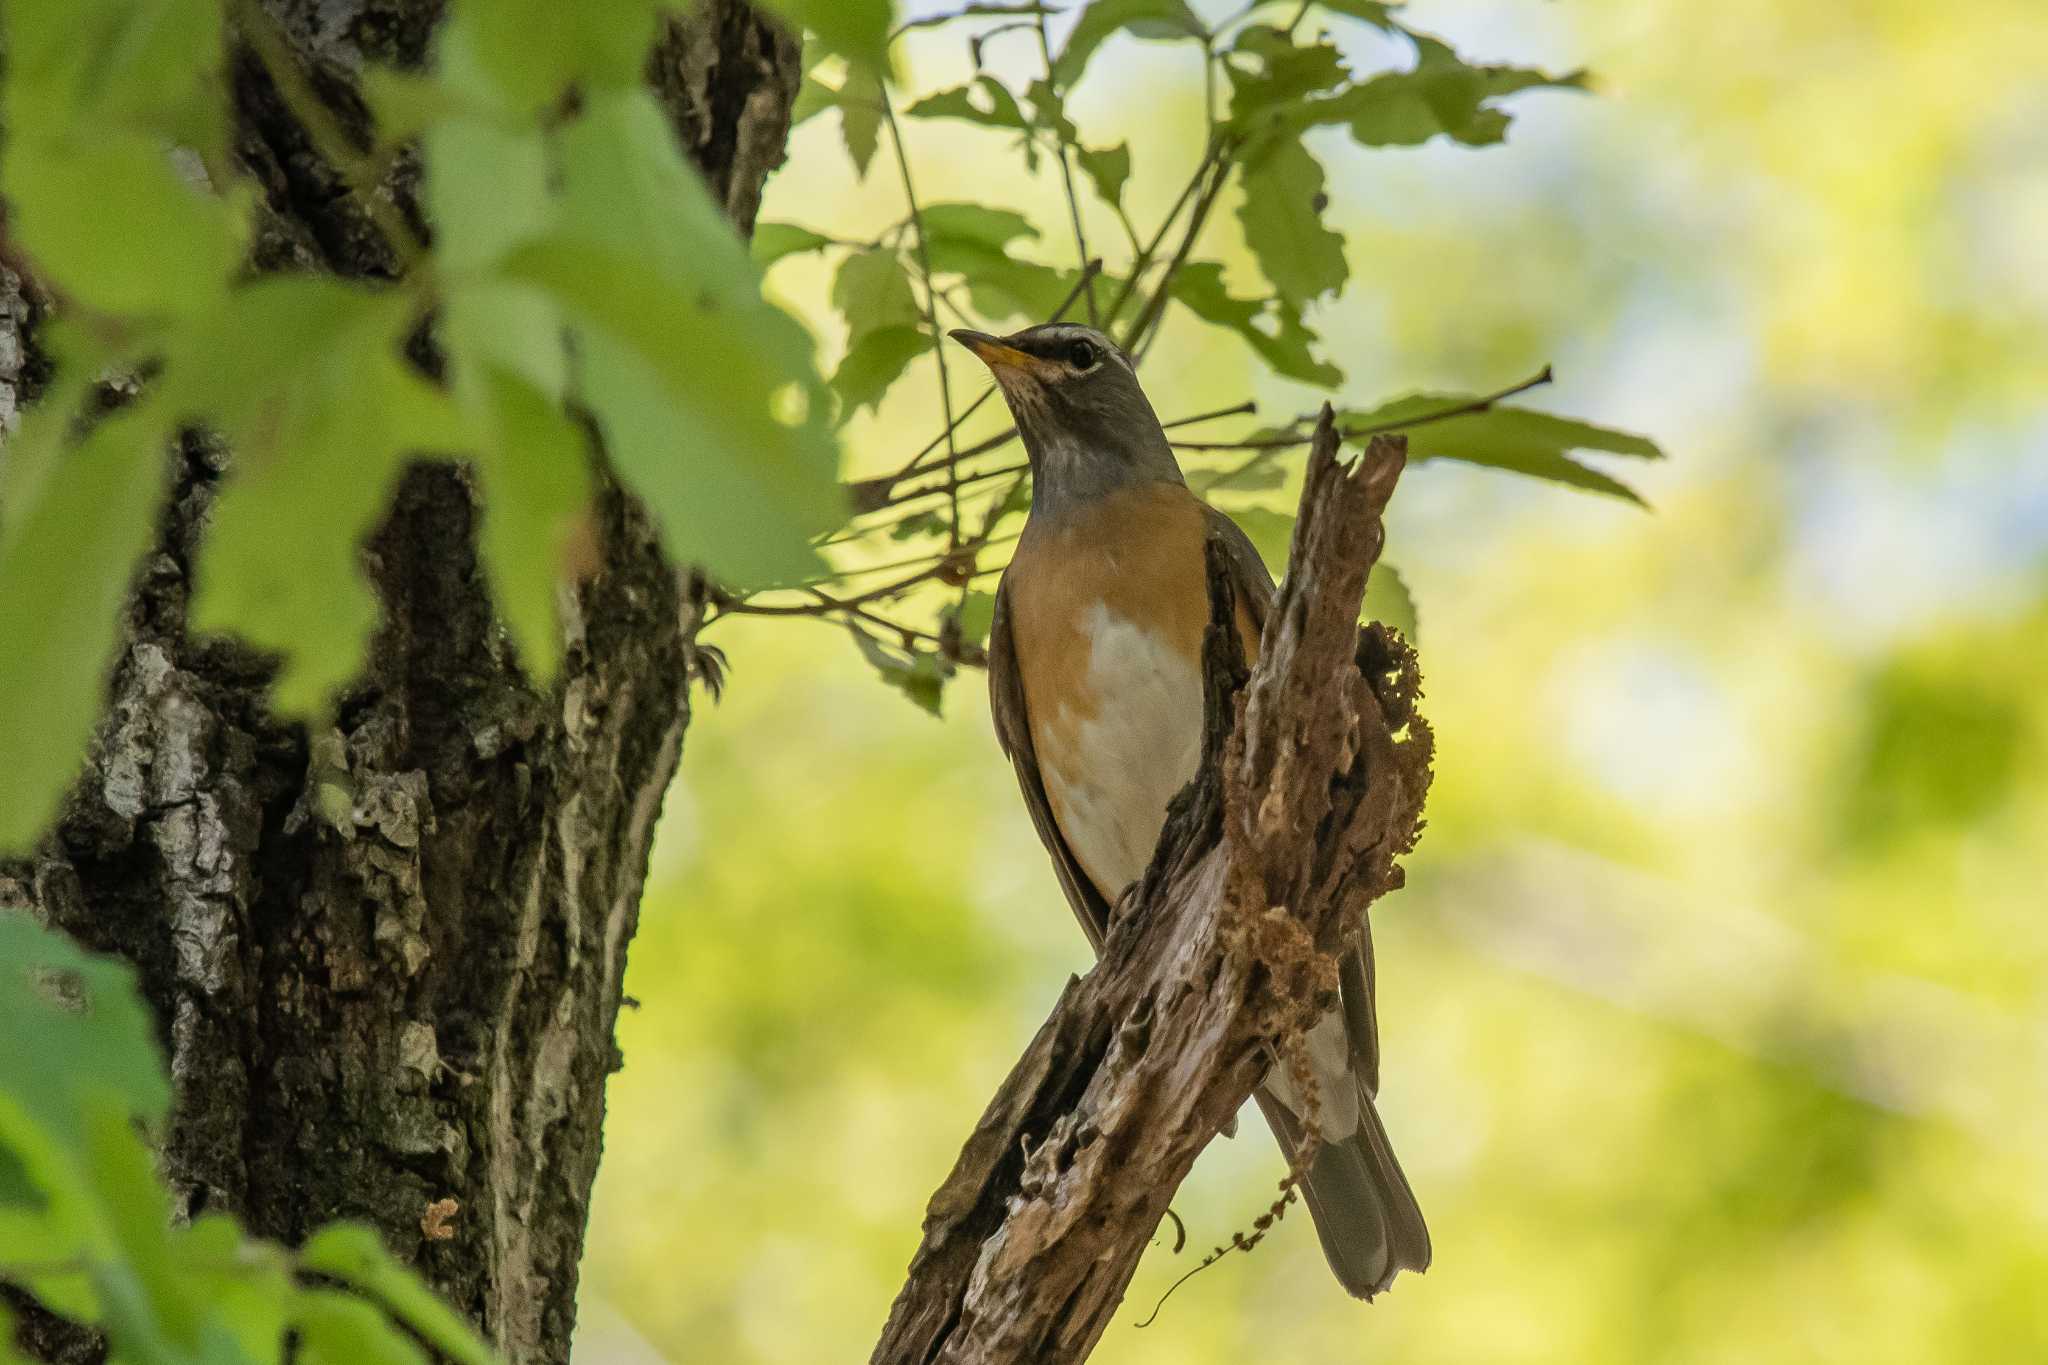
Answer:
[952,321,1182,516]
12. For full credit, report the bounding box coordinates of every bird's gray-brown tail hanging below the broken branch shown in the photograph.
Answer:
[1257,1070,1430,1300]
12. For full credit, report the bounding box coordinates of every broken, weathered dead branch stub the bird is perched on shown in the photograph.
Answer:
[872,417,1432,1365]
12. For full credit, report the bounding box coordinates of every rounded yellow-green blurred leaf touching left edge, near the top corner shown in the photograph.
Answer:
[0,129,242,317]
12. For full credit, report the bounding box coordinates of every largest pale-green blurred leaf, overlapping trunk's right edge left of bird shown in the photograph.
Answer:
[520,90,844,587]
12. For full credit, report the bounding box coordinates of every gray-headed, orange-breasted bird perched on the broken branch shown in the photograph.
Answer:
[950,321,1430,1300]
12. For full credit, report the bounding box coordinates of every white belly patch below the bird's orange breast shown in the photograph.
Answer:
[1032,602,1202,900]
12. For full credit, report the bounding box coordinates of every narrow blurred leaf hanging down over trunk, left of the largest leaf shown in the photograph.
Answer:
[459,370,594,686]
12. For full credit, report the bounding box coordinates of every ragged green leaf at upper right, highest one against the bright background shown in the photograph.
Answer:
[1300,35,1585,147]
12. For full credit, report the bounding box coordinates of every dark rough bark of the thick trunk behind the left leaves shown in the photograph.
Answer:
[0,0,799,1361]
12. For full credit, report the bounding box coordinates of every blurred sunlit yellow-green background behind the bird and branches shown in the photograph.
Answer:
[580,0,2048,1365]
